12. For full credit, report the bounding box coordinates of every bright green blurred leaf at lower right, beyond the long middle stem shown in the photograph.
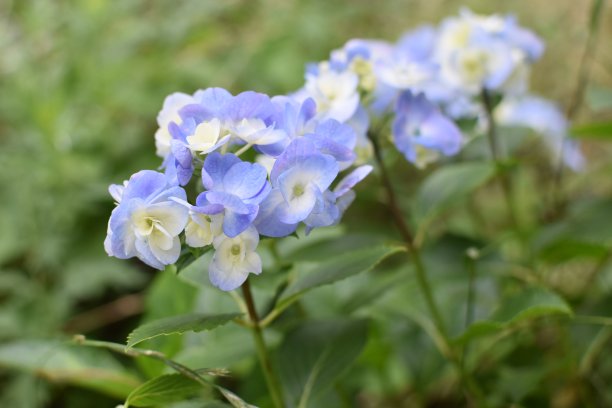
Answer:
[455,288,573,344]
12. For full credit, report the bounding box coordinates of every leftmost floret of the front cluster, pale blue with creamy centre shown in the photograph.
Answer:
[104,170,189,269]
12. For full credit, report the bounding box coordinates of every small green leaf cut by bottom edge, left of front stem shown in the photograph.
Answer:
[125,374,202,407]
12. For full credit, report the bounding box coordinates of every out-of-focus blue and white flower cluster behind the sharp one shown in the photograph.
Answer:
[294,10,581,168]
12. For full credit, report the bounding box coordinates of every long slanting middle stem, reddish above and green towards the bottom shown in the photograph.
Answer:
[368,133,486,407]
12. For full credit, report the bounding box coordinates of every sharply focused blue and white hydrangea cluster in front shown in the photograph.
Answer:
[105,88,372,290]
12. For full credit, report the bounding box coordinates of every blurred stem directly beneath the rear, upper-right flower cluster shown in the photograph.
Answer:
[480,88,520,231]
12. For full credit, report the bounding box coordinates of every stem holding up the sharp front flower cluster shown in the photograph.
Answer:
[242,279,285,408]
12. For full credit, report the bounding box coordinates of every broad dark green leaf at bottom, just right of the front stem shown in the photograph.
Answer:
[277,320,368,408]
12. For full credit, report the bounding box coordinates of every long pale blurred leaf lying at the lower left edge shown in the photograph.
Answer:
[0,340,140,399]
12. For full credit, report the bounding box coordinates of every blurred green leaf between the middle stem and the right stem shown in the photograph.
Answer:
[413,162,495,224]
